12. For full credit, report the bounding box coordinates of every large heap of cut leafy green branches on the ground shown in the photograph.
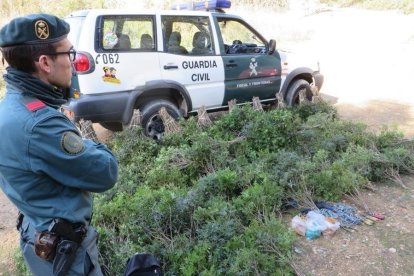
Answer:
[93,102,414,275]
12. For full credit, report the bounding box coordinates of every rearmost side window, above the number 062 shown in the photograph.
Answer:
[98,16,155,52]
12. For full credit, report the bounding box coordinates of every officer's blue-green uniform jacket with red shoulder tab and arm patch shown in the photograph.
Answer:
[0,85,118,231]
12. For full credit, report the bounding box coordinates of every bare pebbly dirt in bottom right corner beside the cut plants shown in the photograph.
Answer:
[294,176,414,276]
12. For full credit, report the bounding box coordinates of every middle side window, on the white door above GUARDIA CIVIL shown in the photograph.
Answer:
[162,16,214,56]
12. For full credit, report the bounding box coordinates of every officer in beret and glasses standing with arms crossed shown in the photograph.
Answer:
[0,14,118,275]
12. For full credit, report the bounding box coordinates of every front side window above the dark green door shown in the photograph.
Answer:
[218,18,266,54]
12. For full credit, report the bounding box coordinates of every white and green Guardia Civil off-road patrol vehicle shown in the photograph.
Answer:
[65,0,323,139]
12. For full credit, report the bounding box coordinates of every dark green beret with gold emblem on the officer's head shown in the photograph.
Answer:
[0,14,70,47]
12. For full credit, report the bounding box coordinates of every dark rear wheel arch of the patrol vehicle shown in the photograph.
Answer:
[122,80,193,124]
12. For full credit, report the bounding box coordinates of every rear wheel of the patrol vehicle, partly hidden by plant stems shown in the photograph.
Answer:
[141,100,181,141]
